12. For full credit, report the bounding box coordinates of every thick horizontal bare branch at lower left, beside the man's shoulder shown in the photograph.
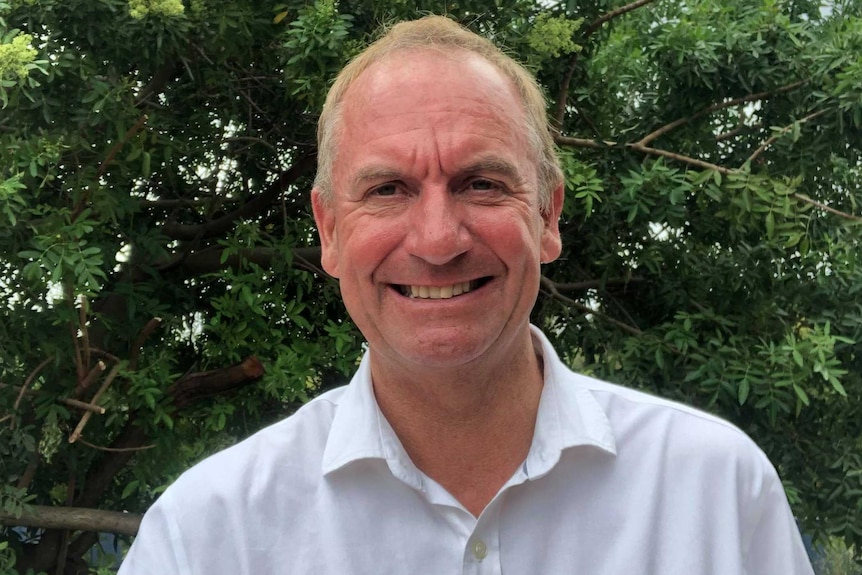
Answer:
[0,505,142,535]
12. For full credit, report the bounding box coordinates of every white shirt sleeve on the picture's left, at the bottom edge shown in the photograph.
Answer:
[117,493,192,575]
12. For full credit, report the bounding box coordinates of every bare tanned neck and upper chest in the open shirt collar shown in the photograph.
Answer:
[371,334,543,517]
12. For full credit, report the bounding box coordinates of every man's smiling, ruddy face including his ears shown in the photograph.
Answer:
[313,51,563,371]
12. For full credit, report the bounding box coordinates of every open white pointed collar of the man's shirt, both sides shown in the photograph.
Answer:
[322,326,616,489]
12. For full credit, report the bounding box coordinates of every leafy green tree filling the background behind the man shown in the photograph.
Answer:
[0,0,862,573]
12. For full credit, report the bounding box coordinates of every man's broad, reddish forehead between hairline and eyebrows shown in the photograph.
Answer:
[335,49,532,180]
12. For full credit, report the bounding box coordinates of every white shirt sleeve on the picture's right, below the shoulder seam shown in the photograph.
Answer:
[745,470,814,575]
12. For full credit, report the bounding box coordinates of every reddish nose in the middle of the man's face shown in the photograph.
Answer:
[405,188,472,266]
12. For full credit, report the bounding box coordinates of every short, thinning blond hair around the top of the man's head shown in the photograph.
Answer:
[314,16,563,212]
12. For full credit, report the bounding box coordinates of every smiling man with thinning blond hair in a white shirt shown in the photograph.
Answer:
[120,17,812,575]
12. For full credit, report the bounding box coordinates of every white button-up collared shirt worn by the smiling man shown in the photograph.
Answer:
[119,328,813,575]
